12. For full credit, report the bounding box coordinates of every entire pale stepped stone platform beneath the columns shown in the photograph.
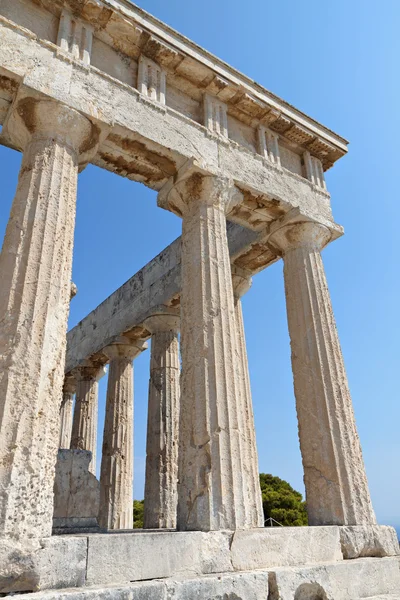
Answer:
[0,526,400,600]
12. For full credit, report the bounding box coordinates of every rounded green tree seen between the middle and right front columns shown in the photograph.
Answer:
[260,473,308,527]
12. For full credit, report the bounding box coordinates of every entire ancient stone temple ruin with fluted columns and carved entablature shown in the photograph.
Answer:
[0,0,400,600]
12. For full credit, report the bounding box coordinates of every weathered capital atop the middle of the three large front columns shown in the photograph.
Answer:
[157,160,243,217]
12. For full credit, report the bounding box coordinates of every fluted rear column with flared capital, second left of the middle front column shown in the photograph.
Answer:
[99,340,147,529]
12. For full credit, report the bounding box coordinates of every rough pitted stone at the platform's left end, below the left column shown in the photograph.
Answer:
[0,537,87,594]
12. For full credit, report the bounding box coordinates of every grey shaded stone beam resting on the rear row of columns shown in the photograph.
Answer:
[66,223,262,373]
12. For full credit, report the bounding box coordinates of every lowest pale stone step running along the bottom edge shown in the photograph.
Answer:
[4,558,400,600]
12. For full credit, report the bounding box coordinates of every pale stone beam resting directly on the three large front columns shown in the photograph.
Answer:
[0,17,332,230]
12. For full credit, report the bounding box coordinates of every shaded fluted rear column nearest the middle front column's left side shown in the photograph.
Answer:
[144,313,180,529]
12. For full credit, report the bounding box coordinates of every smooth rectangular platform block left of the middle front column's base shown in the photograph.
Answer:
[87,531,232,585]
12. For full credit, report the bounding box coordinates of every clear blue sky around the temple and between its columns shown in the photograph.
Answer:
[0,0,400,525]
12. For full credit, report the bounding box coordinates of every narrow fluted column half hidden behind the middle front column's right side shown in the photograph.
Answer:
[232,266,264,527]
